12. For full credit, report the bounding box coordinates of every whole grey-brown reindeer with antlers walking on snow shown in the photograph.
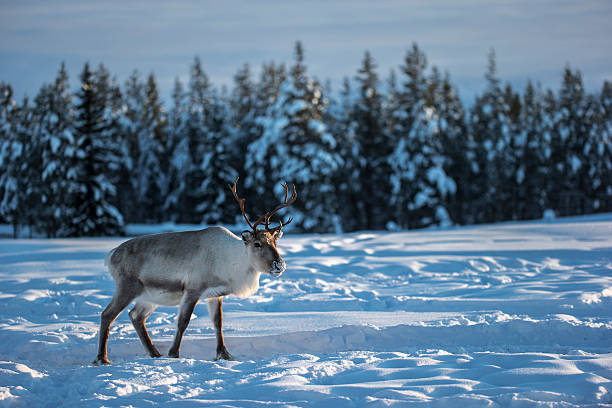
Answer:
[93,179,297,365]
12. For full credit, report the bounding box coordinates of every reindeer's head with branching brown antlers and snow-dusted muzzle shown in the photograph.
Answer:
[230,178,297,276]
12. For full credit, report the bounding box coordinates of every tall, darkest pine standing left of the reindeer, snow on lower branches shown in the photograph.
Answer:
[66,63,124,236]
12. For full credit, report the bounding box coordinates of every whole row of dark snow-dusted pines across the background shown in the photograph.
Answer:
[0,42,612,237]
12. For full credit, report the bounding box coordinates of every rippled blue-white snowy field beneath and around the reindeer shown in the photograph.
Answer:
[0,215,612,408]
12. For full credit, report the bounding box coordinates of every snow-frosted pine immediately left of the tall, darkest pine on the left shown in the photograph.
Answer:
[34,63,77,237]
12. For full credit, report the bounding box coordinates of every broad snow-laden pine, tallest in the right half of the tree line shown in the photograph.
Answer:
[389,44,456,228]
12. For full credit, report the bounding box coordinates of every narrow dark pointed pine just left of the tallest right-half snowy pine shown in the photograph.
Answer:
[352,51,393,230]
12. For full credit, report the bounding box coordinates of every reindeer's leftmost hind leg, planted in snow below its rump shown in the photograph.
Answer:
[93,282,143,365]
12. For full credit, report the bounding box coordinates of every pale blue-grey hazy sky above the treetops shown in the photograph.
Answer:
[0,0,612,103]
